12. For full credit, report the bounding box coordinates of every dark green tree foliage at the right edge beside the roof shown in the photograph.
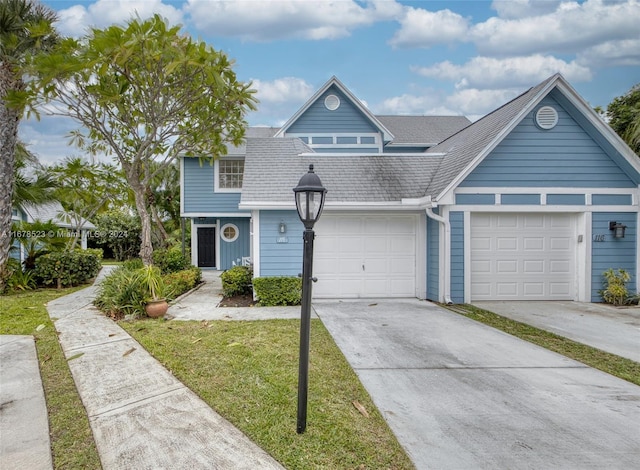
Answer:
[607,83,640,156]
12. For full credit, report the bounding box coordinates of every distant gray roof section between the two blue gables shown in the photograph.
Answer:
[376,116,471,145]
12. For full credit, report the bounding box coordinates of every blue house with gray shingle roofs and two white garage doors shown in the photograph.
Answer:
[181,75,640,303]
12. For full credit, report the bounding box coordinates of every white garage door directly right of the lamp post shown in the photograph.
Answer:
[313,213,417,298]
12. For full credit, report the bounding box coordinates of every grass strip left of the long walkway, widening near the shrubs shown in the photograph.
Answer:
[0,288,101,470]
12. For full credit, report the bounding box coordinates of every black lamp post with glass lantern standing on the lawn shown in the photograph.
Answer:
[293,165,327,434]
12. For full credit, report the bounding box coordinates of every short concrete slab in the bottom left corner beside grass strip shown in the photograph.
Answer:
[0,335,53,470]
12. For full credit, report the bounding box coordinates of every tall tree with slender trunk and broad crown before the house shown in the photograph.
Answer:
[27,15,255,264]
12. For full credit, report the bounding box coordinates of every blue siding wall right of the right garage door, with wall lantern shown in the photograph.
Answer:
[591,212,638,302]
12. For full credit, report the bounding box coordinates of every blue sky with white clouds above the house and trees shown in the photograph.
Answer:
[20,0,640,163]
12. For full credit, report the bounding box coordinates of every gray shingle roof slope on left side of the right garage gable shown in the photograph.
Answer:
[427,75,559,199]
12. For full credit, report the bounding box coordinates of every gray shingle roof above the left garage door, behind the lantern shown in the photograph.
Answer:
[241,138,442,204]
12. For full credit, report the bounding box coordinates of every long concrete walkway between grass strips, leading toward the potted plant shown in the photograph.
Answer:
[47,268,283,470]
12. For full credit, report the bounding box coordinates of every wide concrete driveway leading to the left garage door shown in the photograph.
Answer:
[310,299,640,469]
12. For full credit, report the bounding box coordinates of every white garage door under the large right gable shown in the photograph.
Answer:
[471,214,576,301]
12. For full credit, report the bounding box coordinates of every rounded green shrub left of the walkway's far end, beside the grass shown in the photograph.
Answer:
[33,250,100,288]
